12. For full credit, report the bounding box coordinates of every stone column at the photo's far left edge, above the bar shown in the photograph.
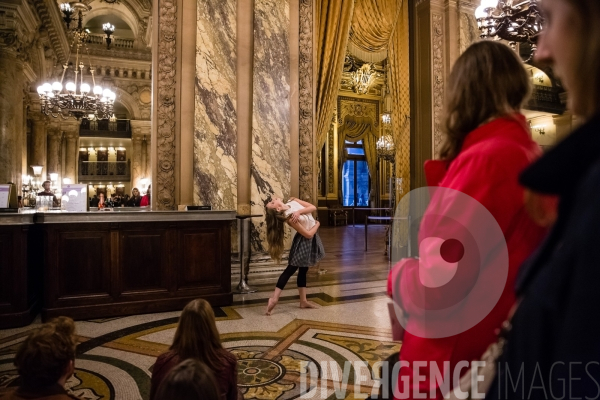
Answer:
[0,49,23,183]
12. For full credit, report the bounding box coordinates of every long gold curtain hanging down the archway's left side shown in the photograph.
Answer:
[315,0,354,151]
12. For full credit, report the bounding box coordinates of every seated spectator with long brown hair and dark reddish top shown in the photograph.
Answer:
[150,299,238,400]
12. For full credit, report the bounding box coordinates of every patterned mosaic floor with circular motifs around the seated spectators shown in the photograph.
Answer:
[0,227,400,400]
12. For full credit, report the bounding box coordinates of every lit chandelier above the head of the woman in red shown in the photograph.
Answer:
[475,0,543,58]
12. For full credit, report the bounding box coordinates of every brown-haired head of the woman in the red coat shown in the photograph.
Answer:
[440,40,531,160]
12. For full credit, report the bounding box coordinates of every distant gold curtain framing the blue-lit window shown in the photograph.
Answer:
[338,115,378,203]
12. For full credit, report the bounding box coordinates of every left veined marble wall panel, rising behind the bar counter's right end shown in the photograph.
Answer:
[194,0,237,210]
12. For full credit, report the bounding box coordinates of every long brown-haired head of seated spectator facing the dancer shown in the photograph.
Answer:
[171,299,223,370]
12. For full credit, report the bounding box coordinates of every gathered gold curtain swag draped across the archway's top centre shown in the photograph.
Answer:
[350,0,398,51]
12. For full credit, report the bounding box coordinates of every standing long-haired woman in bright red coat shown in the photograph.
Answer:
[388,41,545,399]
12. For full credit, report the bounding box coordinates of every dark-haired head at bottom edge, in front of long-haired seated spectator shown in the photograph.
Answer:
[156,358,219,400]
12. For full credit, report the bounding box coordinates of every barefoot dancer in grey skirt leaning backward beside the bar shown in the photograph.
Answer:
[266,197,325,315]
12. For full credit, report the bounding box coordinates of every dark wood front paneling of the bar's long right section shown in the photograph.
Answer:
[40,220,233,319]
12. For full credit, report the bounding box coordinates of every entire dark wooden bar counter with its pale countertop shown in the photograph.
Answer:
[0,209,235,324]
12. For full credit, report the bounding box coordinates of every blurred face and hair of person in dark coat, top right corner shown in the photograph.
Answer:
[535,0,600,119]
